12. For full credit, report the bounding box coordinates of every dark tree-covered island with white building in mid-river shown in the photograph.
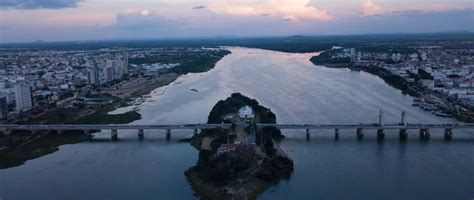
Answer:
[185,93,293,199]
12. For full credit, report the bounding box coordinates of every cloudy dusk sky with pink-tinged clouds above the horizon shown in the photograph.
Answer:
[0,0,474,43]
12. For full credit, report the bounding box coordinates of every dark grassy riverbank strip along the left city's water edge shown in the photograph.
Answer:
[0,49,231,170]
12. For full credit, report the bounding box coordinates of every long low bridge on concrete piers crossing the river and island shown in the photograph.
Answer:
[0,123,474,140]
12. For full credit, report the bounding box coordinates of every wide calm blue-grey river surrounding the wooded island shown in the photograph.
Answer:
[0,47,474,200]
